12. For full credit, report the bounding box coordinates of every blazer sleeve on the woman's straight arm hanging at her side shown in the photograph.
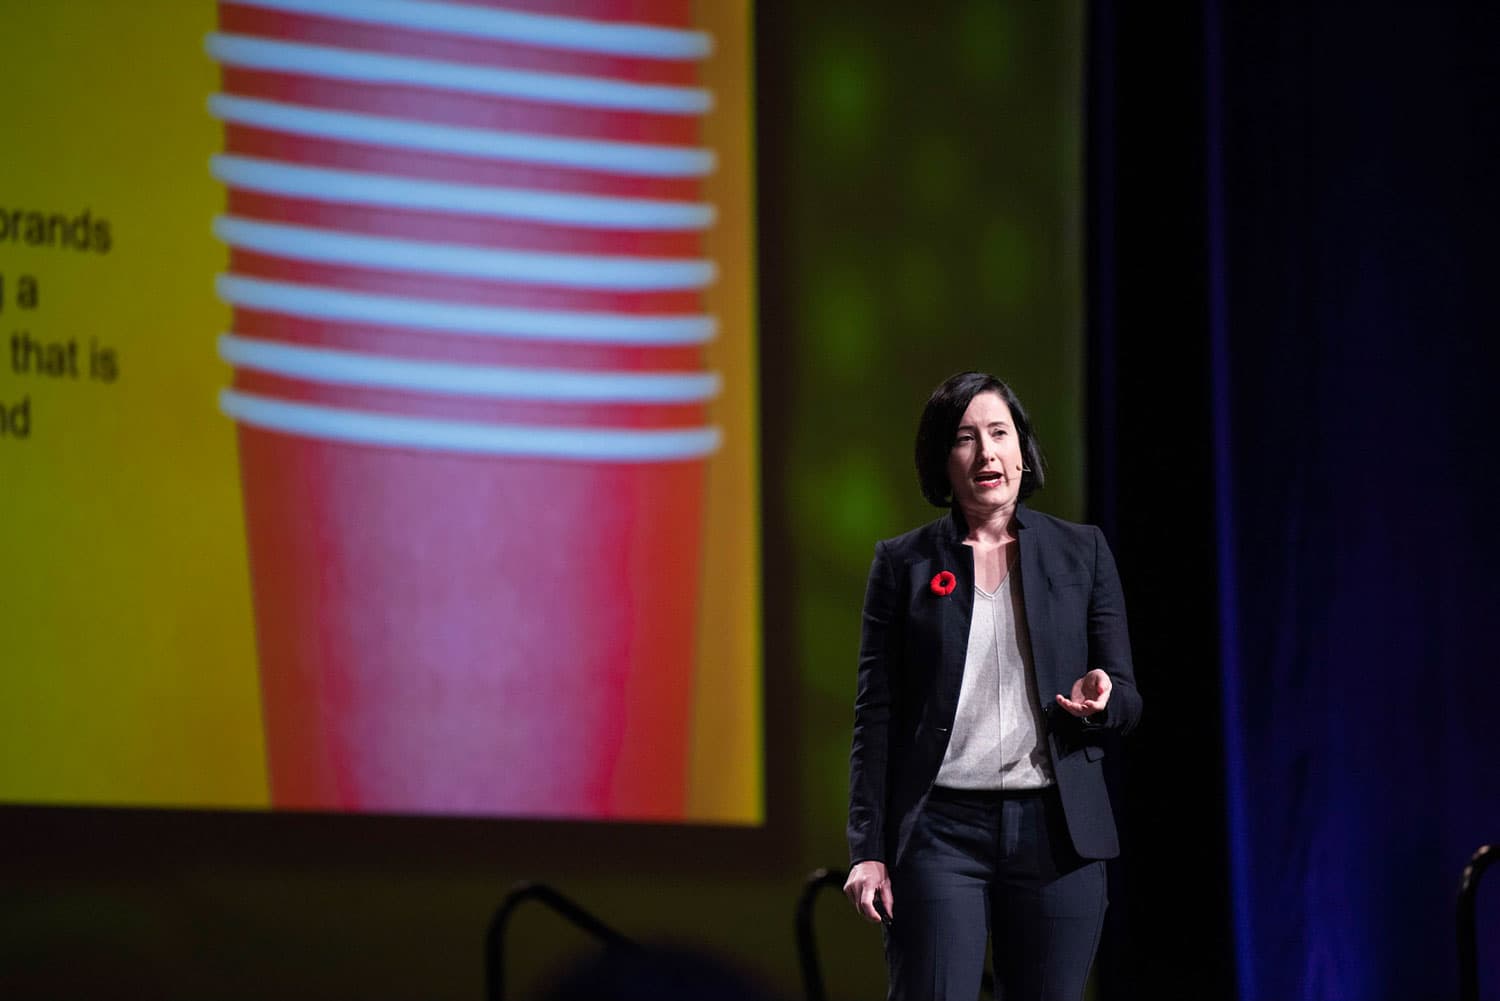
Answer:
[849,543,902,863]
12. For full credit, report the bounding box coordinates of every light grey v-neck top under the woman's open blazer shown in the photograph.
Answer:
[938,567,1053,789]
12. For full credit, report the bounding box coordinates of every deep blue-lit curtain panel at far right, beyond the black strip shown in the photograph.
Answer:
[1203,0,1500,1001]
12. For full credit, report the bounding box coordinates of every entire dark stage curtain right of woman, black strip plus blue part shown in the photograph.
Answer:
[1091,0,1500,1001]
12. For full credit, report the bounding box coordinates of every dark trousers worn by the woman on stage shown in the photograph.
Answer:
[885,788,1107,1001]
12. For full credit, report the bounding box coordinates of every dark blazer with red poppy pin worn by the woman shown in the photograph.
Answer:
[849,506,1140,866]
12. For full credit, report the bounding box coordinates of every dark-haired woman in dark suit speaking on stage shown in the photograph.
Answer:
[845,372,1142,1001]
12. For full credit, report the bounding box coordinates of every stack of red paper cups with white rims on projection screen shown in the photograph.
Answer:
[207,0,720,819]
